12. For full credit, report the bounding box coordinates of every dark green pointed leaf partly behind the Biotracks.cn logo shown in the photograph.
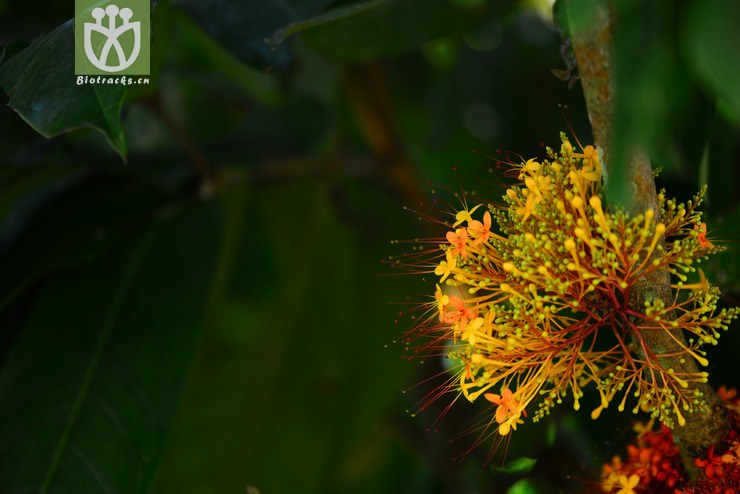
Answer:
[0,21,126,156]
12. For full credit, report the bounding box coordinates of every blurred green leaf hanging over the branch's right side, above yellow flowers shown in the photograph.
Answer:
[608,1,696,206]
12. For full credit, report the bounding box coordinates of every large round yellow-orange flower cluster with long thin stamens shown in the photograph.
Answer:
[419,135,737,435]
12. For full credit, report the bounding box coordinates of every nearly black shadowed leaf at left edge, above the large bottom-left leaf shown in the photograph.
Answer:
[0,174,172,308]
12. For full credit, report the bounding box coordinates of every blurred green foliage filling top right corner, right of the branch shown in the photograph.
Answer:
[558,0,740,210]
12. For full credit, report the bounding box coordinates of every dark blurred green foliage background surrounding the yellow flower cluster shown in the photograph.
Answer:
[0,0,740,494]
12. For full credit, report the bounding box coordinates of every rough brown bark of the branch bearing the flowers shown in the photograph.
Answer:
[569,1,729,478]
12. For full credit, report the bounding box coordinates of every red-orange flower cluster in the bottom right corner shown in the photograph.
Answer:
[601,386,740,494]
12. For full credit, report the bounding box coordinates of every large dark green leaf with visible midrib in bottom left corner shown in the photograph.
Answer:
[0,199,219,494]
